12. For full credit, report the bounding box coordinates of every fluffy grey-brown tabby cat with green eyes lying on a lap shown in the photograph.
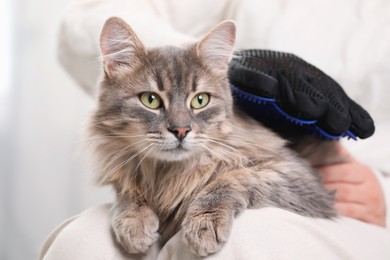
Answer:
[90,17,337,256]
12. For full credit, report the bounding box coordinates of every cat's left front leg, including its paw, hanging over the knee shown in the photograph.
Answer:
[111,193,159,253]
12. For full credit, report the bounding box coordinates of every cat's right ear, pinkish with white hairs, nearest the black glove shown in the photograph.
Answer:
[196,20,236,68]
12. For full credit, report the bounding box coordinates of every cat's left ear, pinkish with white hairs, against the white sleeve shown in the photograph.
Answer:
[100,17,145,76]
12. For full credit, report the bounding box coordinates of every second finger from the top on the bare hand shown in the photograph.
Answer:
[324,182,365,205]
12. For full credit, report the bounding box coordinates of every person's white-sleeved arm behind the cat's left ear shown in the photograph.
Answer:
[58,0,192,95]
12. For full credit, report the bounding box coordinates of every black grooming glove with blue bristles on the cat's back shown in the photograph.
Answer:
[229,49,375,138]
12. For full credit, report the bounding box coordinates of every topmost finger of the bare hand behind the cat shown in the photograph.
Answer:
[318,163,364,184]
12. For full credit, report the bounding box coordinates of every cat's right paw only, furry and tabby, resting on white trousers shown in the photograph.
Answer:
[182,211,233,256]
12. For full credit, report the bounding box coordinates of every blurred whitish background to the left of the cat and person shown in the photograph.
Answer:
[0,0,111,260]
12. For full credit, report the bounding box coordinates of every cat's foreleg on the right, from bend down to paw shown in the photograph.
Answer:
[182,176,247,256]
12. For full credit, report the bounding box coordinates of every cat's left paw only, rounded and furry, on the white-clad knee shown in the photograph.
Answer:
[112,207,160,253]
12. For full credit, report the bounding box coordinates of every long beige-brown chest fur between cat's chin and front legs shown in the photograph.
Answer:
[137,158,221,240]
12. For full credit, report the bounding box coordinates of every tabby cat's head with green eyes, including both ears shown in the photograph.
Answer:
[94,18,235,161]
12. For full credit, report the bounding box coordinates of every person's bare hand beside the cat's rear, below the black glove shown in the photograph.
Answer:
[318,146,386,226]
